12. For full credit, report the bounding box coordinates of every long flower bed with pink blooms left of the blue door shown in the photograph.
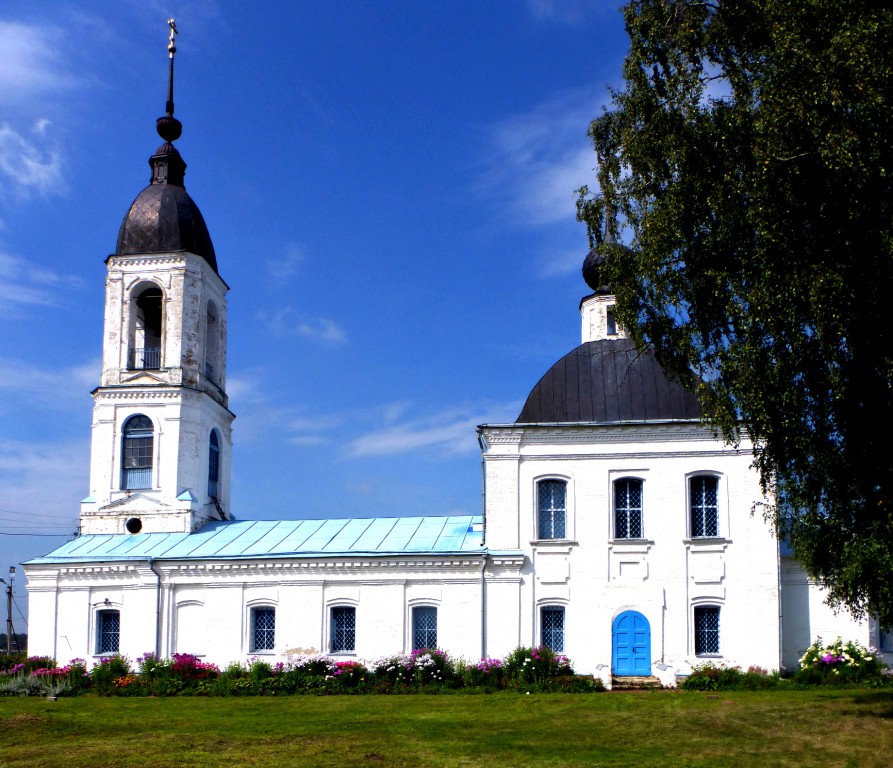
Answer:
[0,647,604,696]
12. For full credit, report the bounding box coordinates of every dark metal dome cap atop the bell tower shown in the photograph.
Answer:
[115,184,217,272]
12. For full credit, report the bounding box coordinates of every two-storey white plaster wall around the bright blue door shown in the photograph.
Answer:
[483,424,780,672]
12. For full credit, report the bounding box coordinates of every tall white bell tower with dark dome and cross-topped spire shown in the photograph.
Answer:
[81,19,235,534]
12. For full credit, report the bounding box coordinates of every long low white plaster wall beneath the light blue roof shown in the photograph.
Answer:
[26,556,502,665]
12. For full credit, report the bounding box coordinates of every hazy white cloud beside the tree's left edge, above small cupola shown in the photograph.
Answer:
[480,88,604,227]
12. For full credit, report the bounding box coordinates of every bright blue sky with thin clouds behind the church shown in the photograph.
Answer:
[0,0,627,629]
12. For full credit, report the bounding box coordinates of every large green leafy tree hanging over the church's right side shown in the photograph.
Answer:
[578,0,893,625]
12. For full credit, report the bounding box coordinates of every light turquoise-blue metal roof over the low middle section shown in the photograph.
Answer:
[28,515,485,565]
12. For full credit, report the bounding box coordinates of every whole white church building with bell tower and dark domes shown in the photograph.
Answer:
[25,45,893,684]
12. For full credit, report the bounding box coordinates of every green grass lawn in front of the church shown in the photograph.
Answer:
[0,690,893,768]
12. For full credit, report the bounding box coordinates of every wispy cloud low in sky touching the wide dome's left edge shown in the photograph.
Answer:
[347,402,521,457]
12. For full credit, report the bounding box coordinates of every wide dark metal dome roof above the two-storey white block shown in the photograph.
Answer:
[515,339,701,424]
